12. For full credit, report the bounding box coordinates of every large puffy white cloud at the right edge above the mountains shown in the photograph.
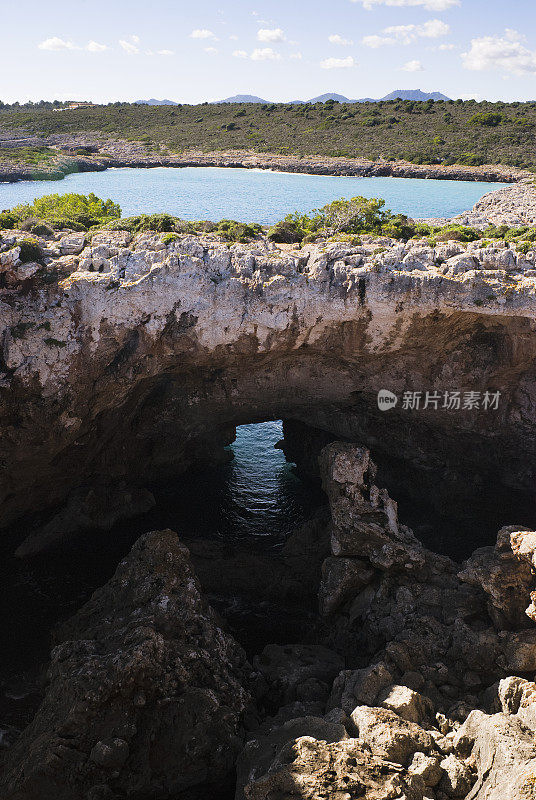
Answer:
[462,29,536,75]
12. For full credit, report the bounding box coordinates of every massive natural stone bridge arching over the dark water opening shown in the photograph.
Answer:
[0,231,536,544]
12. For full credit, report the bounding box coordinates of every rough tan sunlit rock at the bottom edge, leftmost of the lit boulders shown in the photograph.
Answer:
[244,736,424,800]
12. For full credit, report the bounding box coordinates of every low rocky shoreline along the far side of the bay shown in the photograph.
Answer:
[0,131,534,183]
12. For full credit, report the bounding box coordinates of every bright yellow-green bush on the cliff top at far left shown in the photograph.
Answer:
[0,193,121,231]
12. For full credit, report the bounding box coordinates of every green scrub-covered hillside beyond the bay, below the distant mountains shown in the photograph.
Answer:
[0,100,536,169]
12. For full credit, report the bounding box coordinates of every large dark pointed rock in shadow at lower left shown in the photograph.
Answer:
[0,531,250,800]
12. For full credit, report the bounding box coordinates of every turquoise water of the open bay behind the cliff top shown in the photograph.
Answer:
[0,167,504,223]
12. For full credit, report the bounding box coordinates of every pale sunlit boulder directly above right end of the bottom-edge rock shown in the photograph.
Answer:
[351,706,434,765]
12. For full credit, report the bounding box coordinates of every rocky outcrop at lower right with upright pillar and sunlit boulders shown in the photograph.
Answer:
[230,442,536,800]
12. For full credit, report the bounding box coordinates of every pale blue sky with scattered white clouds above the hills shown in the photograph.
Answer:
[0,0,536,103]
